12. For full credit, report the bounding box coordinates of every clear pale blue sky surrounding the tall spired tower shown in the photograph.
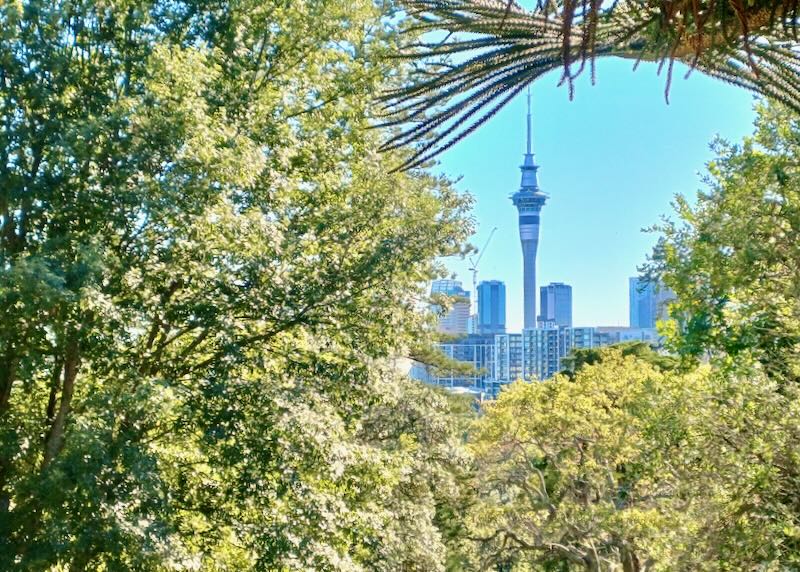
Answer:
[440,60,755,331]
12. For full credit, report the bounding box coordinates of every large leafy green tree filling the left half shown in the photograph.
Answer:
[0,0,470,570]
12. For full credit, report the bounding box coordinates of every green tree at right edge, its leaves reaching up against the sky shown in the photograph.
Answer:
[648,103,800,382]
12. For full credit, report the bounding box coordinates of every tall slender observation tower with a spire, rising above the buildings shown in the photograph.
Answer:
[511,88,547,329]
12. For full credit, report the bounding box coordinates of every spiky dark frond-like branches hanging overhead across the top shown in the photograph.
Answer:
[383,0,800,169]
